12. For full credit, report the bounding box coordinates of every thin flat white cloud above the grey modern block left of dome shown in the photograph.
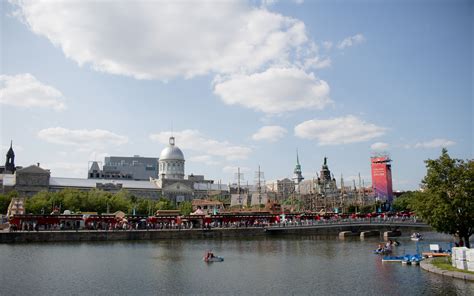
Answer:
[38,127,128,151]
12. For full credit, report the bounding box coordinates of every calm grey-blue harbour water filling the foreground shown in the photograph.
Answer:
[0,233,474,295]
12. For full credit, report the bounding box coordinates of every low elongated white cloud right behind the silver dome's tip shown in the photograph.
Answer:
[150,130,252,160]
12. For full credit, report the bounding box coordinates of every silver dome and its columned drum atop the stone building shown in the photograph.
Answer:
[159,137,184,180]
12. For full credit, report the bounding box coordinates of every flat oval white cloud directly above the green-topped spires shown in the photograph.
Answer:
[295,115,386,145]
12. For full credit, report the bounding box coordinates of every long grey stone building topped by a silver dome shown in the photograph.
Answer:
[0,137,220,203]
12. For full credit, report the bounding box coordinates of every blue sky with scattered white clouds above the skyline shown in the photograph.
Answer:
[0,0,474,190]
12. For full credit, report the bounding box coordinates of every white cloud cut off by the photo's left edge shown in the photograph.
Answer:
[0,73,66,111]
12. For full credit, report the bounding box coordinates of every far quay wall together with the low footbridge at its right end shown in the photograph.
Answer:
[0,219,431,243]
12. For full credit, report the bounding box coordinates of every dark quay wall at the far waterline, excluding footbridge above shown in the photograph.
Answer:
[0,225,427,243]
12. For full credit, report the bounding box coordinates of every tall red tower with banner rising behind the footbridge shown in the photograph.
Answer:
[370,155,393,204]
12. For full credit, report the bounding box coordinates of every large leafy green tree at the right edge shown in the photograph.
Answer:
[411,149,474,247]
